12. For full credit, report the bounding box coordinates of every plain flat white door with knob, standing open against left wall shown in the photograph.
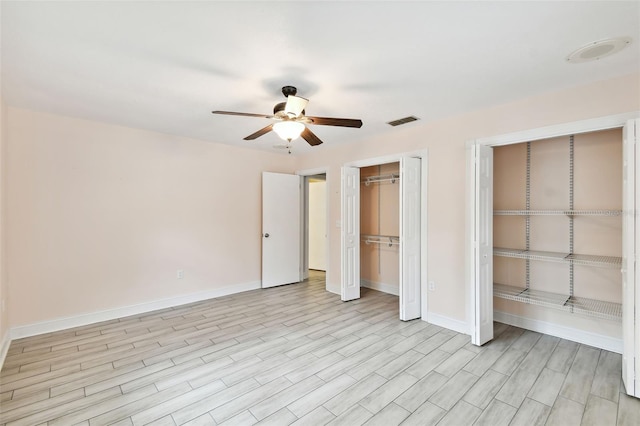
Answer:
[262,172,302,288]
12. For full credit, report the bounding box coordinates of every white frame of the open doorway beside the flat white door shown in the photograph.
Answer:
[295,167,331,282]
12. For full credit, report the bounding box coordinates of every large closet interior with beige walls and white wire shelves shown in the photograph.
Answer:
[493,128,622,330]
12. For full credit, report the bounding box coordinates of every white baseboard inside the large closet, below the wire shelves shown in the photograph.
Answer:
[493,311,622,354]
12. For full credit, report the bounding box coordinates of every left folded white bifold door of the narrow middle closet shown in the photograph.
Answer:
[340,167,360,301]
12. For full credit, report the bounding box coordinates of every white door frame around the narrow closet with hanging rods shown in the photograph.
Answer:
[340,149,428,321]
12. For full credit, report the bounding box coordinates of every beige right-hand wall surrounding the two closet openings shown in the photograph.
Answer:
[297,74,640,321]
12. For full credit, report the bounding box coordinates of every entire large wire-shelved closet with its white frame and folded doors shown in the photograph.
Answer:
[466,112,640,397]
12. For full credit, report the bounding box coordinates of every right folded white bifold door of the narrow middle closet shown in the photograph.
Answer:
[400,157,422,321]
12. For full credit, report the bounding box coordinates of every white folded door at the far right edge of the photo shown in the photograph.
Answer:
[622,120,640,397]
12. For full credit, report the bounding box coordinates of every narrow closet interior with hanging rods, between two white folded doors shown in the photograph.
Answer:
[360,162,400,296]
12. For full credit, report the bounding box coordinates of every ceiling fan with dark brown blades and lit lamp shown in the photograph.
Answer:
[211,86,362,154]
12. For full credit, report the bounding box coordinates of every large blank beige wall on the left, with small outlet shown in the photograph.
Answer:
[6,108,294,327]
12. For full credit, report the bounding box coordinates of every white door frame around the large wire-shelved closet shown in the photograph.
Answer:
[465,111,640,392]
